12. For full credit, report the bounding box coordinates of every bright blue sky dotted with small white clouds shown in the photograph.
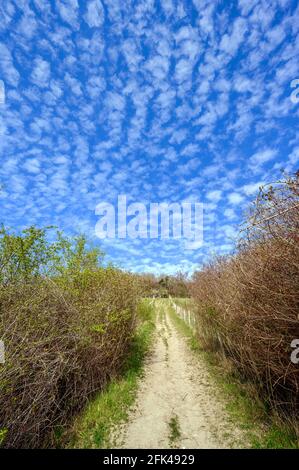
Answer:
[0,0,299,273]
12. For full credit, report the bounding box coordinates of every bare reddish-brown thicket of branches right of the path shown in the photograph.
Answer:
[192,175,299,418]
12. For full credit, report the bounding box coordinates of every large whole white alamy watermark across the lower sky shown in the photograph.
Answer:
[95,195,203,246]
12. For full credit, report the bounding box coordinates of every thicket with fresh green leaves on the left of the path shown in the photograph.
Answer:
[0,227,138,447]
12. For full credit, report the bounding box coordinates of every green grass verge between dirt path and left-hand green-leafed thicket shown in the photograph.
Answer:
[65,300,155,449]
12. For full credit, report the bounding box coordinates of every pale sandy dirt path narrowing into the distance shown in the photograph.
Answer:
[116,300,246,449]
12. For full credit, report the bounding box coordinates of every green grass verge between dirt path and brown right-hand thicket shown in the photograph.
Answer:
[168,304,299,449]
